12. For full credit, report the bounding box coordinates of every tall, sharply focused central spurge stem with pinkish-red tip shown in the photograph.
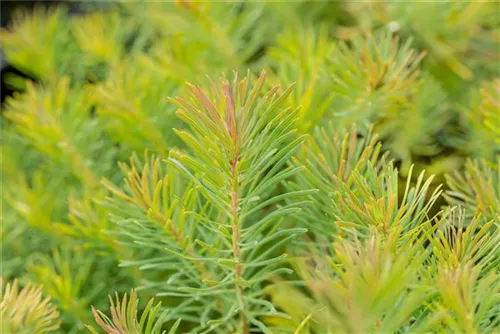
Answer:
[169,73,312,333]
